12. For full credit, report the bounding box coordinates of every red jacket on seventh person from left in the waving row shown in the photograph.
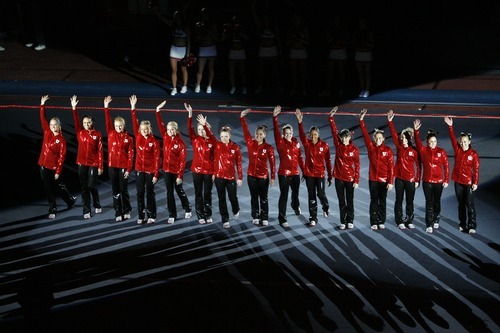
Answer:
[204,126,243,180]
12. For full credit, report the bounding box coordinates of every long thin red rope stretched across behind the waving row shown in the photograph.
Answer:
[0,104,500,119]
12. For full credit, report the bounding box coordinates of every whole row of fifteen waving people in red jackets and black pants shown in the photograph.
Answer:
[39,96,479,233]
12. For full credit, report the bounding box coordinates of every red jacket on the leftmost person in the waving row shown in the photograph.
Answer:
[38,105,66,175]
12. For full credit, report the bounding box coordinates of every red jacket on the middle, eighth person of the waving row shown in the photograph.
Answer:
[240,117,276,180]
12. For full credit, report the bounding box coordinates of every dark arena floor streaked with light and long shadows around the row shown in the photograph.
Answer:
[0,6,500,333]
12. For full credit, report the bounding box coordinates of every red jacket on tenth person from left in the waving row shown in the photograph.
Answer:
[299,123,333,181]
